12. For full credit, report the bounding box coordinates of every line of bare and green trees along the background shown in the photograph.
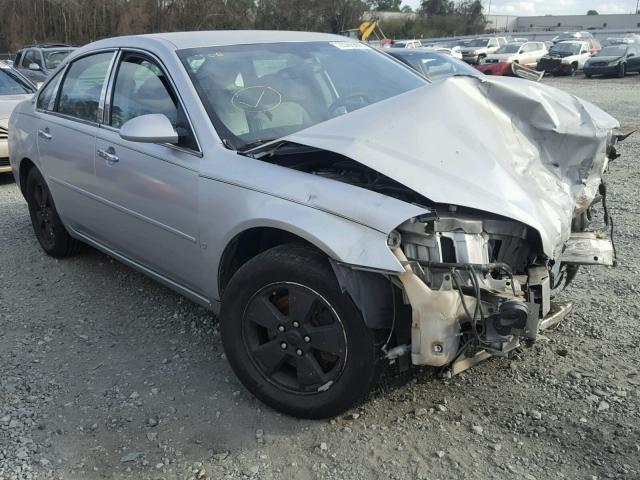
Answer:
[0,0,485,51]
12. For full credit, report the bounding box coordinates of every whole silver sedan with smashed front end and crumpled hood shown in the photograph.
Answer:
[10,31,618,418]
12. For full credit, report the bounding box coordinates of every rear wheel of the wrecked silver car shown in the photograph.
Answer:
[25,168,83,258]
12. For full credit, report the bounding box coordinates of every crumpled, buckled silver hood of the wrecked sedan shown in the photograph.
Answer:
[285,77,619,258]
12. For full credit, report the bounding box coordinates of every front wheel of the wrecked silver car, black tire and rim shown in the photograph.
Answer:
[220,244,382,419]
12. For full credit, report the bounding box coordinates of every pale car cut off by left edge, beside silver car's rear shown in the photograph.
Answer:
[0,61,36,173]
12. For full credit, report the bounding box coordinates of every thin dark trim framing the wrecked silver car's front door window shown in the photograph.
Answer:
[98,47,204,158]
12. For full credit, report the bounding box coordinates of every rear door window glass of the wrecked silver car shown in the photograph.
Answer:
[58,52,113,122]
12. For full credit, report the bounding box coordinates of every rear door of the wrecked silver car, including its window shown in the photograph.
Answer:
[37,51,115,233]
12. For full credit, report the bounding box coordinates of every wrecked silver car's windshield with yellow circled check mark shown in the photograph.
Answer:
[178,41,426,150]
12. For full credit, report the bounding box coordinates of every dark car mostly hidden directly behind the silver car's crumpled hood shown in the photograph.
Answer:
[387,48,481,82]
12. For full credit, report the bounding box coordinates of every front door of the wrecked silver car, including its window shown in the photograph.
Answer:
[93,52,202,293]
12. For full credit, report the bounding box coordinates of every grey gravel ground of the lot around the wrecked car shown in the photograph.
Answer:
[0,75,640,480]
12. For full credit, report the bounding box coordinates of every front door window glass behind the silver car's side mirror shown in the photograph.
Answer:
[109,54,197,150]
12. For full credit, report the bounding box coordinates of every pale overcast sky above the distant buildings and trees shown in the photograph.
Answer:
[403,0,636,16]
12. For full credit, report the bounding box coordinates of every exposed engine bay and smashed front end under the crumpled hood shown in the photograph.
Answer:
[256,133,615,373]
